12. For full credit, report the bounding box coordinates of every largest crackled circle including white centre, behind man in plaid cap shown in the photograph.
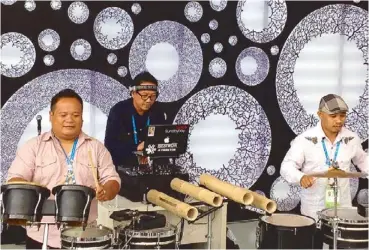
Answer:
[276,4,368,139]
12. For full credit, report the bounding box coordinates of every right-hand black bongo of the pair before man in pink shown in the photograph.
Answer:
[52,185,96,224]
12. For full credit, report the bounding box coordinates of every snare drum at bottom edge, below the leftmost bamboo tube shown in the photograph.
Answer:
[118,225,177,249]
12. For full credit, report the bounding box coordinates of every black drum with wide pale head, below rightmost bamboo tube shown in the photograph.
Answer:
[256,213,316,249]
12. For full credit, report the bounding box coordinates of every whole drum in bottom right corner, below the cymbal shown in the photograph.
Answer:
[318,207,369,249]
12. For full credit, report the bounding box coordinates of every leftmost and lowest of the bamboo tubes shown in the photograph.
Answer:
[147,189,199,221]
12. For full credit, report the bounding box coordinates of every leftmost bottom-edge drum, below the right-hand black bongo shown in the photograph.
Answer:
[61,226,113,249]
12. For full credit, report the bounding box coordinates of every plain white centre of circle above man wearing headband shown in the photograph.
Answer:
[145,42,179,81]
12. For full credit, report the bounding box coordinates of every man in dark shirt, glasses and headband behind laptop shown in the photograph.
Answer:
[105,72,167,166]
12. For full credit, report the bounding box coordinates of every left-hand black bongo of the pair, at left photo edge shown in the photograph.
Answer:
[1,182,50,225]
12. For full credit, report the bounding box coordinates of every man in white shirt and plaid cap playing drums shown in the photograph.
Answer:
[280,94,368,248]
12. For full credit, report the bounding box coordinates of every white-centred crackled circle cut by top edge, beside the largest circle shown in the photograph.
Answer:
[236,0,287,43]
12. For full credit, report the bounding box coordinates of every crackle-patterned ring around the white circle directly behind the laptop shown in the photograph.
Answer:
[174,85,272,188]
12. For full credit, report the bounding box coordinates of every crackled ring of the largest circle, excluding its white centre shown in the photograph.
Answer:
[276,4,368,139]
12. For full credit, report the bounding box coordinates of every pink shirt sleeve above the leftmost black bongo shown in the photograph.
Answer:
[7,138,37,181]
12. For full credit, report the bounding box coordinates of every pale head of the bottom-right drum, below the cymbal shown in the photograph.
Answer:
[319,207,368,223]
